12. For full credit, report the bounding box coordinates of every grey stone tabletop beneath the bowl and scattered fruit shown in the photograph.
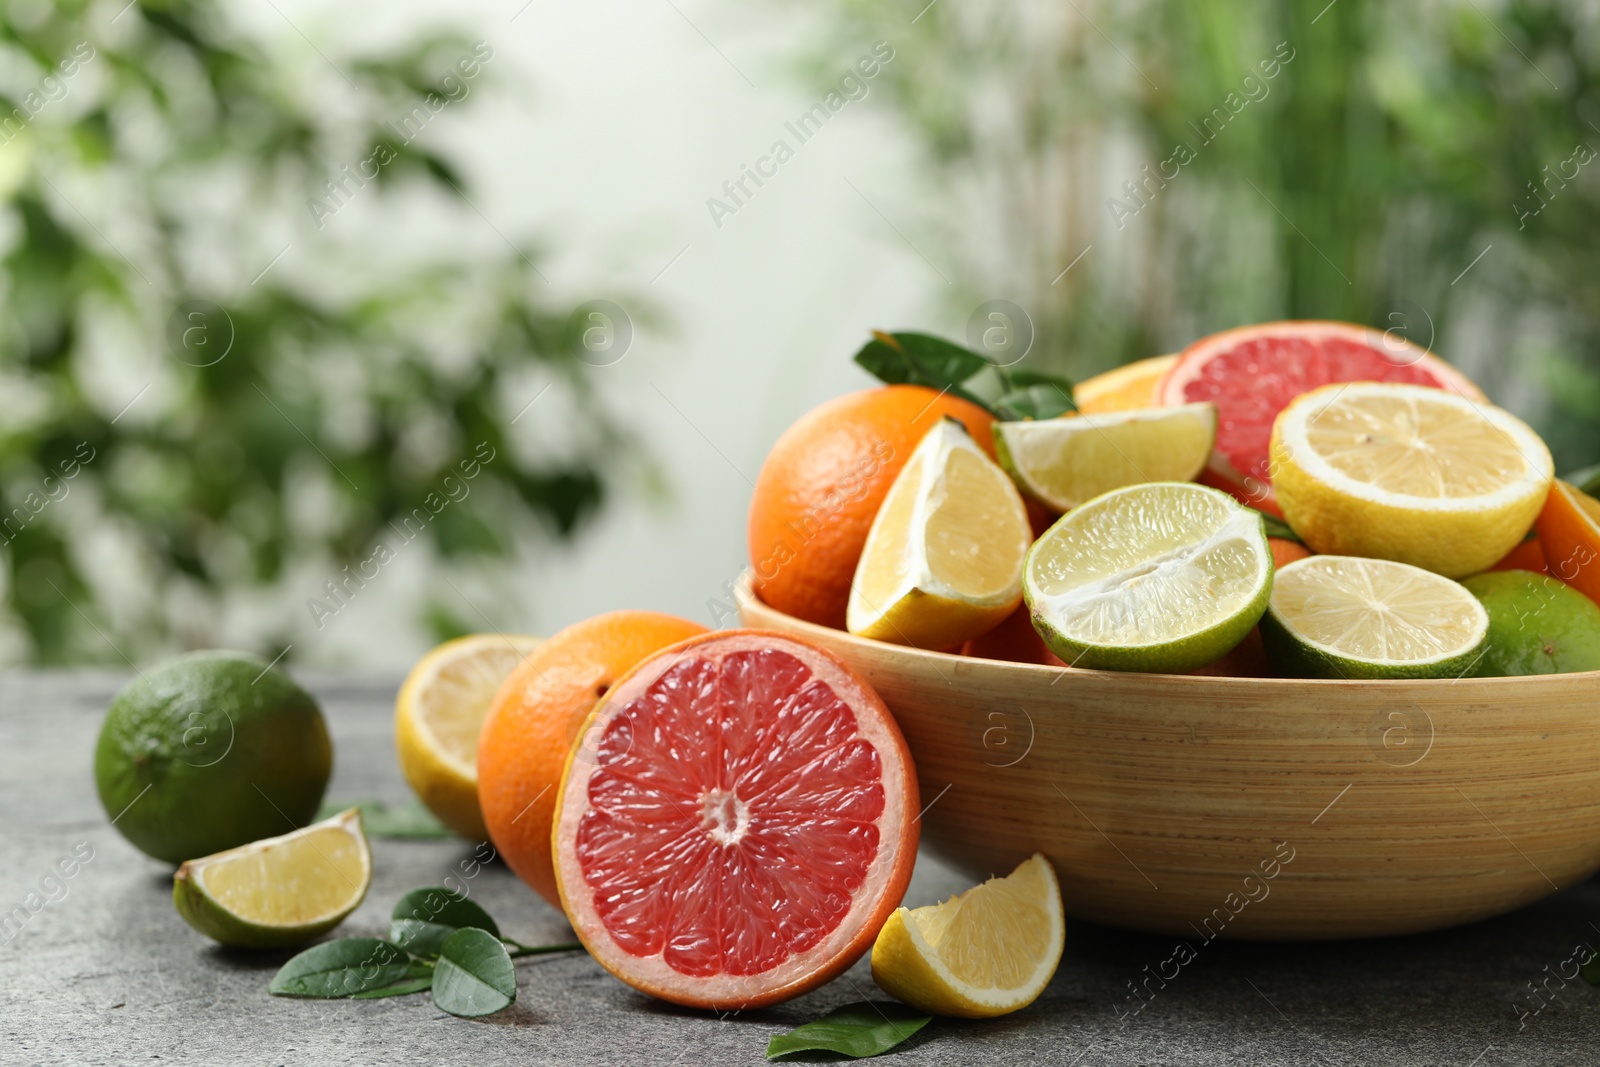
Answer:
[0,672,1600,1067]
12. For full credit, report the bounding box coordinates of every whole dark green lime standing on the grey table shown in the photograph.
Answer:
[94,649,333,864]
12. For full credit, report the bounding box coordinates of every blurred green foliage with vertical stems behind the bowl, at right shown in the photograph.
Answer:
[810,0,1600,469]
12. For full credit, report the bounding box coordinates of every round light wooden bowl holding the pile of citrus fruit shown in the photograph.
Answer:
[736,574,1600,945]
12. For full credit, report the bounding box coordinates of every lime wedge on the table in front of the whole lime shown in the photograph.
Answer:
[173,808,373,949]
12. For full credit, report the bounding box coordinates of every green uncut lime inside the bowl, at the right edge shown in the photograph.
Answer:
[1462,571,1600,677]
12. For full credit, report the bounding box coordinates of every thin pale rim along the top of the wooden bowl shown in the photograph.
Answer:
[733,568,1600,701]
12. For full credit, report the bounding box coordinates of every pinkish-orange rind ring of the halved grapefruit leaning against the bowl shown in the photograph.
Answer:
[550,630,920,1011]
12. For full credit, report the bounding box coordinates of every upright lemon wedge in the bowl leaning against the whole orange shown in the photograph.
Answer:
[845,419,1034,648]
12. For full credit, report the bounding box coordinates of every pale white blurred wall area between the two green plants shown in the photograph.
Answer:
[237,0,963,665]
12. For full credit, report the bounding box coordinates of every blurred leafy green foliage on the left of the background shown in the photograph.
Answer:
[0,0,630,664]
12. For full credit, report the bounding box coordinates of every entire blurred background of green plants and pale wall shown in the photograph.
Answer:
[0,0,1600,665]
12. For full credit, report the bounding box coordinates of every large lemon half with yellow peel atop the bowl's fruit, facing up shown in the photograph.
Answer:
[1272,382,1554,577]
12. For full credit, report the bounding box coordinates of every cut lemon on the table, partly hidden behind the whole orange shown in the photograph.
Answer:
[395,633,539,841]
